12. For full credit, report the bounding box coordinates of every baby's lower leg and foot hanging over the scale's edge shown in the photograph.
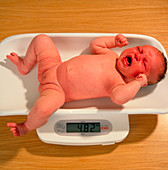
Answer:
[7,89,65,136]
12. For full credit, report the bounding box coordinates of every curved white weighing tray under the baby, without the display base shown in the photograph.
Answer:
[0,33,168,116]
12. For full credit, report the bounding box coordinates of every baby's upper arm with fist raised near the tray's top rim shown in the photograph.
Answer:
[90,34,128,54]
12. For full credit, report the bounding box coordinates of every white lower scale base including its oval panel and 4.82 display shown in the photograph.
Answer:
[37,110,129,146]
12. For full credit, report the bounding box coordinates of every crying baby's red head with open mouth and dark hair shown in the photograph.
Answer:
[117,45,167,85]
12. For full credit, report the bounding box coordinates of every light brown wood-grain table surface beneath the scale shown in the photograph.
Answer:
[0,0,168,170]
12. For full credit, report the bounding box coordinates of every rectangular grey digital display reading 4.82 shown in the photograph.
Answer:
[66,122,100,133]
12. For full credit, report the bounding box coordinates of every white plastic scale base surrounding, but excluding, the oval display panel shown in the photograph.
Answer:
[37,112,129,146]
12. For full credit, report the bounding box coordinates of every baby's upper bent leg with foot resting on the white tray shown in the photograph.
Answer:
[6,34,61,75]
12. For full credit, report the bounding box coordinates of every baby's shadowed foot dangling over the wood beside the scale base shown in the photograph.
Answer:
[7,123,29,137]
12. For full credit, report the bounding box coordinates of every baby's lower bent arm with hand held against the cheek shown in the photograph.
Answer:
[111,74,147,105]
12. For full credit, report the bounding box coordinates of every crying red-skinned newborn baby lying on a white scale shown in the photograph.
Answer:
[7,34,167,136]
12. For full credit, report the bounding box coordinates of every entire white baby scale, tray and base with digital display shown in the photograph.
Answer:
[0,33,168,146]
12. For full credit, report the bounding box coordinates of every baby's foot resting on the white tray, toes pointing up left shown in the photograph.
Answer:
[6,52,28,75]
